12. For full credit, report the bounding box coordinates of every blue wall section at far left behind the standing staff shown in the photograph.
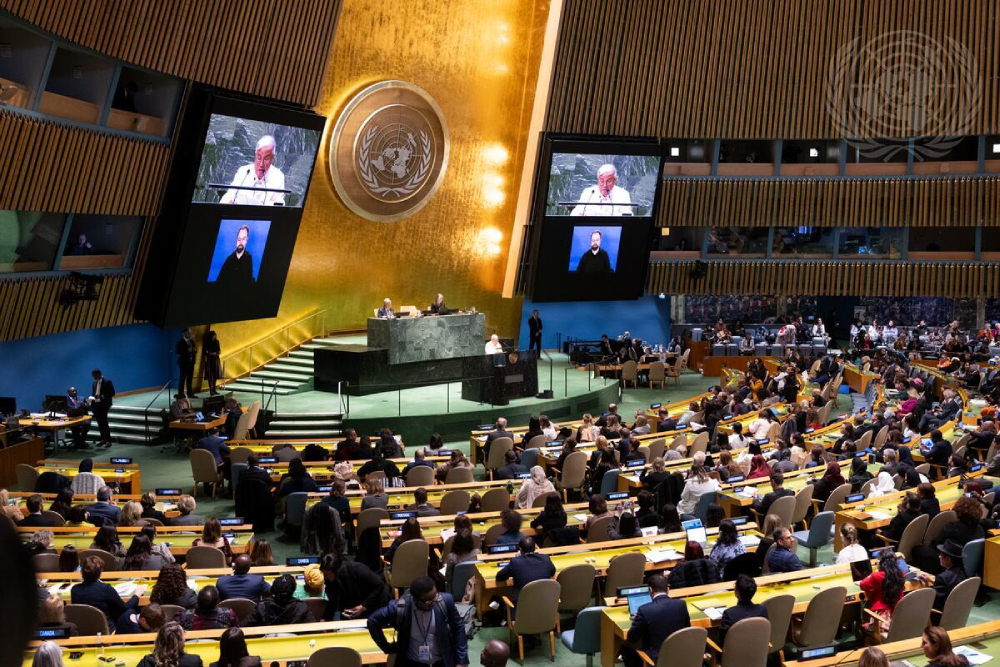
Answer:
[0,324,180,410]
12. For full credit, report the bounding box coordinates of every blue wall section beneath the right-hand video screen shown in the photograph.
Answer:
[518,296,670,349]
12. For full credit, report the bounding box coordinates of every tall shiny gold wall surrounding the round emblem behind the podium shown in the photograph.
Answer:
[215,0,548,350]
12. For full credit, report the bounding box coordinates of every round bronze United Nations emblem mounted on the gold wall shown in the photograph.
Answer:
[330,81,448,222]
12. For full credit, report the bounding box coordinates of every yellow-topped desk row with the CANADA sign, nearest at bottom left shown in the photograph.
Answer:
[21,619,392,667]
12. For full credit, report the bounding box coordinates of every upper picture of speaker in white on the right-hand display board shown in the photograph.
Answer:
[545,152,660,218]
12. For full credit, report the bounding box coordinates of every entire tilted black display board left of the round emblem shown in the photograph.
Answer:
[137,87,326,326]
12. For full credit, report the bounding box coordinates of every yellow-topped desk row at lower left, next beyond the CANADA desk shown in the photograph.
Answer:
[35,565,305,607]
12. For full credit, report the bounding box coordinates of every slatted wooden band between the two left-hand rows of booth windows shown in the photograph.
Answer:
[0,109,170,216]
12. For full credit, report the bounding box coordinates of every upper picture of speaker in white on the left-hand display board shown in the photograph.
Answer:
[191,113,322,207]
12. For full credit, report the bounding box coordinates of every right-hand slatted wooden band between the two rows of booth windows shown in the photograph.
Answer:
[656,177,1000,227]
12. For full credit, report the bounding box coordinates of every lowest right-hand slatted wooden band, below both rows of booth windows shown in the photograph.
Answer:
[646,260,1000,298]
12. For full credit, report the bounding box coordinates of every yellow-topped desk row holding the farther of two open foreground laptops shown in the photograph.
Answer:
[475,523,760,618]
